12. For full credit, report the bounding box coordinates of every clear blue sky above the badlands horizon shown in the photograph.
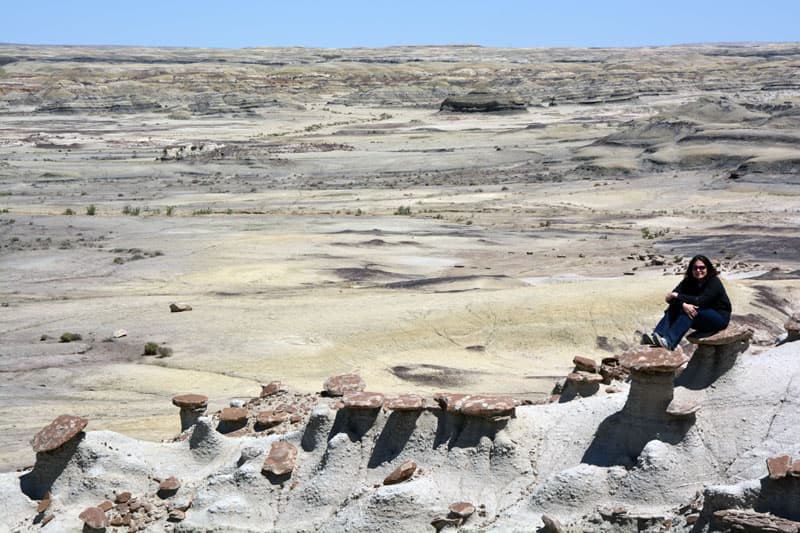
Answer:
[0,0,800,48]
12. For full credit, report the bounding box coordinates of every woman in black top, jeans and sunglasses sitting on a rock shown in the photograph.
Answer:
[652,255,731,350]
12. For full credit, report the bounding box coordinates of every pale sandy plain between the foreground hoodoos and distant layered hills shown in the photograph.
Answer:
[0,44,800,470]
